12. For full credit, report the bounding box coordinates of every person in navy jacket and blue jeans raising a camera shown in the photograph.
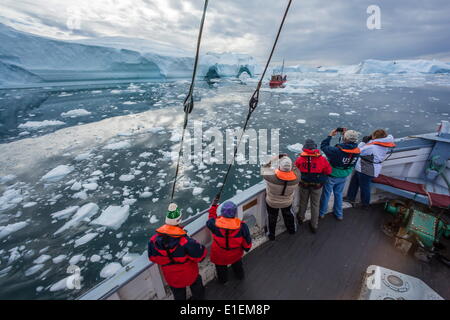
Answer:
[319,128,360,221]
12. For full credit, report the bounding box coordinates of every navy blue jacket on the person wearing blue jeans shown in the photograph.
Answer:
[320,136,360,178]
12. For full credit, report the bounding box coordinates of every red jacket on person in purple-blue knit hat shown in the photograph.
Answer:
[206,205,252,266]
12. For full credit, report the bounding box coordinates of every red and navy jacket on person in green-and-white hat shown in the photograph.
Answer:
[148,225,207,288]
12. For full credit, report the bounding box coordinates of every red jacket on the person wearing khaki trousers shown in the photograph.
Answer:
[295,149,332,187]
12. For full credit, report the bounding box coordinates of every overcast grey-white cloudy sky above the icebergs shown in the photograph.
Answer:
[0,0,450,65]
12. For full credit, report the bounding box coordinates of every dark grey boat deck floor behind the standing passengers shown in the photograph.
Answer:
[206,205,450,300]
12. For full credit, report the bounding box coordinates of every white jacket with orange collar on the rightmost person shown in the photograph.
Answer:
[355,135,394,178]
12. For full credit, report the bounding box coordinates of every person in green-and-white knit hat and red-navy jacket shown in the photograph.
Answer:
[148,203,207,300]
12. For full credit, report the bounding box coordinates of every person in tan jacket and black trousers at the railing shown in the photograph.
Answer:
[261,154,300,241]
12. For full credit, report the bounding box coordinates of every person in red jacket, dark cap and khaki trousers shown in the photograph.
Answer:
[295,139,332,233]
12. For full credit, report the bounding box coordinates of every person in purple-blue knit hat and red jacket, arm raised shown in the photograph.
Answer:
[206,197,252,283]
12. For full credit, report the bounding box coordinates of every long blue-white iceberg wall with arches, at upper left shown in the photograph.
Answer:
[0,23,257,85]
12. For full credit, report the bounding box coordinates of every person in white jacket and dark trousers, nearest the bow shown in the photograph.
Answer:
[344,129,395,209]
